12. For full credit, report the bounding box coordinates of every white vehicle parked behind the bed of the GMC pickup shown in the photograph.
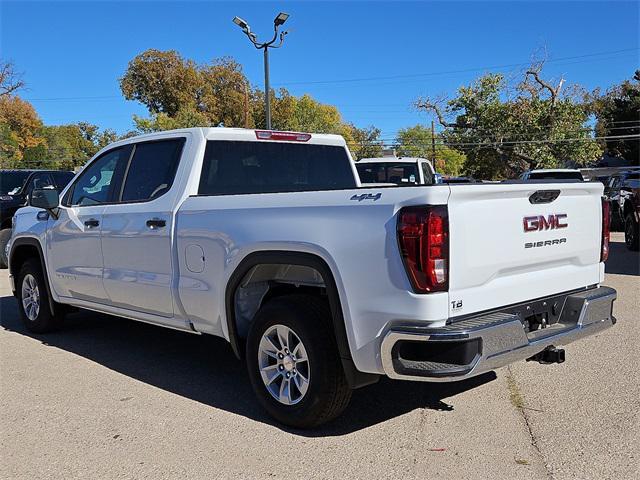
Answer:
[356,157,437,185]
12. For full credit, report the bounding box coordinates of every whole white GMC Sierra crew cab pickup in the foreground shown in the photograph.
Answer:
[9,128,616,427]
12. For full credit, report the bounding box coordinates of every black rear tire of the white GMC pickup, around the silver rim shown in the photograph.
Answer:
[246,295,351,428]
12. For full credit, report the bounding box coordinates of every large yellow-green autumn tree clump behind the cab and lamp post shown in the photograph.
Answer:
[120,49,382,158]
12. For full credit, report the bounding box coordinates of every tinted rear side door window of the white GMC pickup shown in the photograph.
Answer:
[120,138,185,202]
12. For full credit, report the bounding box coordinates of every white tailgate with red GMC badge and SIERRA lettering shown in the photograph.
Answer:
[448,182,603,317]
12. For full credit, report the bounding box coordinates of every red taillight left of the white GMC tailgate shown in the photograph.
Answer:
[398,206,449,293]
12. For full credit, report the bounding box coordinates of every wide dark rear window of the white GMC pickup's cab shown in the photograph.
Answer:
[198,140,356,195]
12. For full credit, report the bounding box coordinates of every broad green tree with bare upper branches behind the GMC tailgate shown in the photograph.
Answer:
[416,64,602,179]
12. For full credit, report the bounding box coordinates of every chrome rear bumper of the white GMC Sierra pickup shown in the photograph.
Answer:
[380,287,616,382]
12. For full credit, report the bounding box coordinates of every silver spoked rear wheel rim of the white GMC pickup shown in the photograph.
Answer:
[258,325,311,405]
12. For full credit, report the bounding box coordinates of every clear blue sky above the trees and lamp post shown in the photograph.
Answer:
[0,0,640,138]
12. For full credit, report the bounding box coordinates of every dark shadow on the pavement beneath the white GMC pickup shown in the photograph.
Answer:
[0,296,496,437]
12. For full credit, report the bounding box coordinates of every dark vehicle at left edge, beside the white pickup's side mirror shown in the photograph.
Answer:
[0,170,74,268]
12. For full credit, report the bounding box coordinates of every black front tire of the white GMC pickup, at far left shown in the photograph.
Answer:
[16,258,64,333]
